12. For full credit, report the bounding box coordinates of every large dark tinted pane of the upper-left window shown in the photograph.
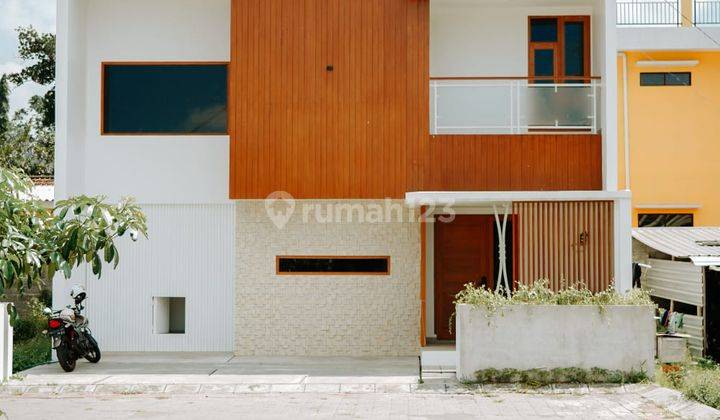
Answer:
[103,64,227,134]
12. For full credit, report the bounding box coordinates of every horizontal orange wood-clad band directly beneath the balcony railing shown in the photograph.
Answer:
[424,134,602,191]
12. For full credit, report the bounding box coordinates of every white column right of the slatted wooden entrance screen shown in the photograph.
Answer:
[613,196,632,293]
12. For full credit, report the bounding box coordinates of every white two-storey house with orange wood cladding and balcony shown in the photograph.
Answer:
[54,0,632,355]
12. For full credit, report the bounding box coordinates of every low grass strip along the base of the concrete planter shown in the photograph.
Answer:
[474,368,648,387]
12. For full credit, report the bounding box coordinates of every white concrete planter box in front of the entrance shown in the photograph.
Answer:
[456,305,655,380]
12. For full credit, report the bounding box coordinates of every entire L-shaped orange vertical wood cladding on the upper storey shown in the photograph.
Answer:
[229,0,602,199]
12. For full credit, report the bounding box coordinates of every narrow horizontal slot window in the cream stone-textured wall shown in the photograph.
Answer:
[277,256,390,275]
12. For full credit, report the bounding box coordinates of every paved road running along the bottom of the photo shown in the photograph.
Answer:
[0,393,674,420]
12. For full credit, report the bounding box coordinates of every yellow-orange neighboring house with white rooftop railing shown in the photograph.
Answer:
[617,0,720,226]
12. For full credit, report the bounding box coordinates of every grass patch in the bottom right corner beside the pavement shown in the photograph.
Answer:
[657,359,720,409]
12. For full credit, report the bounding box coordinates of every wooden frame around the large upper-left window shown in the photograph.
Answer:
[100,61,229,137]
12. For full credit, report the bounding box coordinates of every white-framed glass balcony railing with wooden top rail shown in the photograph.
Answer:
[430,78,599,134]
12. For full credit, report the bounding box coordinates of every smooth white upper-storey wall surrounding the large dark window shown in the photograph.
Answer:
[56,0,230,203]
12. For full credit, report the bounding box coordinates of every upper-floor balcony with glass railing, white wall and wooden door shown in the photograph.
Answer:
[429,0,615,136]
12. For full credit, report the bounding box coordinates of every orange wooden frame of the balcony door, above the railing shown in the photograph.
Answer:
[527,15,592,83]
